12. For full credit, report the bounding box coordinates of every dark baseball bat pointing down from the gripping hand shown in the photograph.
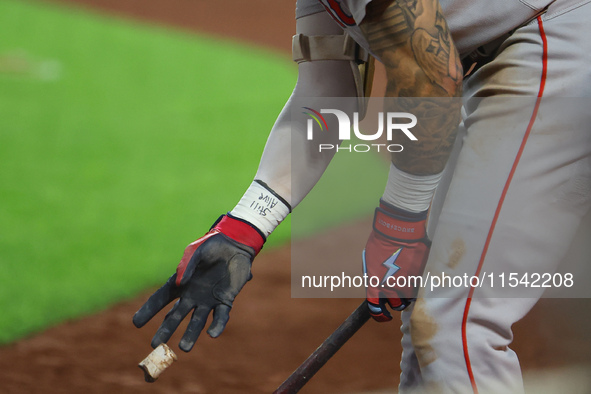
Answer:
[274,300,370,394]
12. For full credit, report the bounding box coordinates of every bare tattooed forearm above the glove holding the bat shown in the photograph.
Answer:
[360,0,462,174]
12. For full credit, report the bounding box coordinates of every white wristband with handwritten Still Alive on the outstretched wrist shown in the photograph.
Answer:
[230,180,291,237]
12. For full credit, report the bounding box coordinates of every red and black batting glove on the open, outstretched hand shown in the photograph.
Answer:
[133,215,265,352]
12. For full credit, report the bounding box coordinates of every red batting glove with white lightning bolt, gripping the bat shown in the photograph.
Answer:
[363,200,431,322]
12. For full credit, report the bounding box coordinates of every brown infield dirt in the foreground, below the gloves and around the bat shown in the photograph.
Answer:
[0,225,408,394]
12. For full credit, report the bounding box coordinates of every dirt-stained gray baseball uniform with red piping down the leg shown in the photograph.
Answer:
[296,0,591,393]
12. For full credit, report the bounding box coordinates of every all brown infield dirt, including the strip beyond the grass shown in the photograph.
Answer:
[0,0,591,394]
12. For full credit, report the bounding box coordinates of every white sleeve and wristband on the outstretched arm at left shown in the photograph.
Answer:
[230,12,357,237]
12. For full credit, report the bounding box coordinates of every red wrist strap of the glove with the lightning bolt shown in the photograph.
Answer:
[373,201,428,241]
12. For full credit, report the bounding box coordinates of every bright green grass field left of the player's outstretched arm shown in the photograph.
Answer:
[0,1,296,343]
